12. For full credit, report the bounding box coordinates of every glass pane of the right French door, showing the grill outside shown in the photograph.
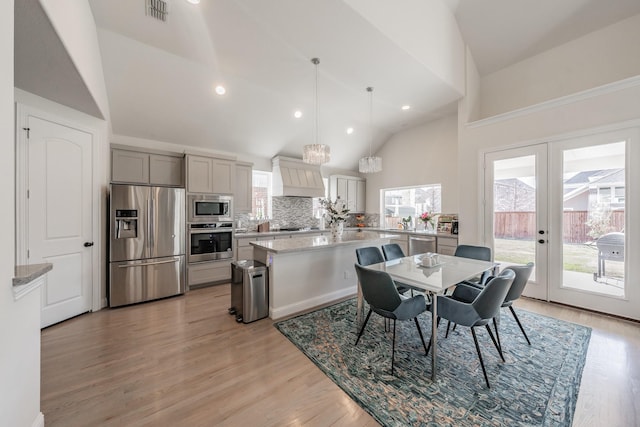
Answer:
[562,142,625,296]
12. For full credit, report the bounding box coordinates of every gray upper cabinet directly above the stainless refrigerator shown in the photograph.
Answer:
[111,148,184,187]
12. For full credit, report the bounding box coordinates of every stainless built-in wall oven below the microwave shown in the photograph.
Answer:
[188,222,233,263]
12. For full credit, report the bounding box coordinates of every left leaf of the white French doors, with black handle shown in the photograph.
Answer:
[484,144,549,300]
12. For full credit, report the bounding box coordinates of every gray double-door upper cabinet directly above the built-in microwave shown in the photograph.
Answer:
[187,155,236,194]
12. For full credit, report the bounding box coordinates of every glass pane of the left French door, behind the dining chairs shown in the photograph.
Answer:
[493,155,536,280]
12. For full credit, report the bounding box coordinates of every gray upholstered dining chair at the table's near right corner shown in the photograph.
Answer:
[427,269,516,388]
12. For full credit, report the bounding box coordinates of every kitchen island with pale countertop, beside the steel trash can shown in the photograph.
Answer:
[251,231,395,319]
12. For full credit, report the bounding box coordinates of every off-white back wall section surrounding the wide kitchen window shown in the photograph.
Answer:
[365,114,458,213]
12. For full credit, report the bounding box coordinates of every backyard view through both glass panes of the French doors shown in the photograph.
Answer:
[493,142,626,296]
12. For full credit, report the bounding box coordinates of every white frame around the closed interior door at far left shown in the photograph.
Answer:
[15,102,104,311]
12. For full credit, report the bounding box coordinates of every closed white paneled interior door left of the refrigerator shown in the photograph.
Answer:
[27,116,93,327]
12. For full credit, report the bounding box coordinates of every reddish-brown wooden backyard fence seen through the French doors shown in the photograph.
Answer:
[493,211,624,243]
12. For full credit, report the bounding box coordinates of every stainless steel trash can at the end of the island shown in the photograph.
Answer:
[229,260,269,323]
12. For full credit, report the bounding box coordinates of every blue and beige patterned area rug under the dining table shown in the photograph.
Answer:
[275,299,591,427]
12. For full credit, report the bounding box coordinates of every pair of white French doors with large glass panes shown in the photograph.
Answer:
[484,129,638,317]
